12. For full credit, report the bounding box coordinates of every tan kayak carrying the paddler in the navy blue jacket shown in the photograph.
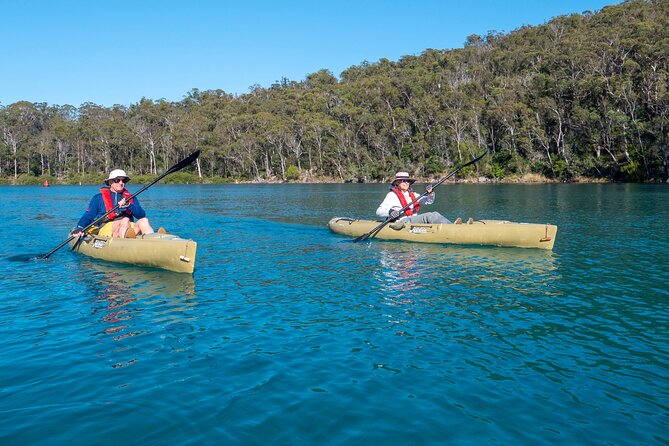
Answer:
[70,231,197,273]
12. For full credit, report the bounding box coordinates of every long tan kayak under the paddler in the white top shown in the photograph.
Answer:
[328,217,557,249]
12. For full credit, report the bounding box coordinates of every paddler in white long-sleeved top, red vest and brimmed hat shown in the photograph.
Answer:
[376,172,471,229]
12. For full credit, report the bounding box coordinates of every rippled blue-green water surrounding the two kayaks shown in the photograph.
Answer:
[0,184,669,445]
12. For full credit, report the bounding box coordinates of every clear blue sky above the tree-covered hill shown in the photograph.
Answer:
[0,0,620,107]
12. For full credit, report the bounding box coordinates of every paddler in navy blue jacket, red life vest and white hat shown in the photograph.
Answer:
[71,169,154,238]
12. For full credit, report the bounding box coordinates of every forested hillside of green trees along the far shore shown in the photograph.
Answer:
[0,0,669,183]
